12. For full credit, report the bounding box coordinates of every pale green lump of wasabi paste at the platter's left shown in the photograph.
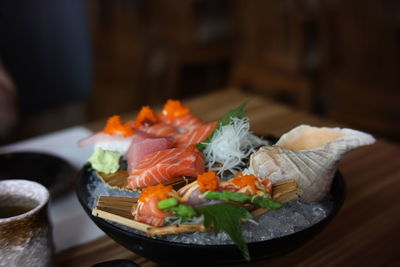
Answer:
[89,148,121,174]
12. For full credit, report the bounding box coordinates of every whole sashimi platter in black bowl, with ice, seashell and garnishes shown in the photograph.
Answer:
[78,100,375,262]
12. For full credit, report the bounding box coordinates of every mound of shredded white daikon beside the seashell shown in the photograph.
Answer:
[203,117,267,176]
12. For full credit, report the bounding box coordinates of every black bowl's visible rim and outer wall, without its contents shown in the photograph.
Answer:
[77,165,345,265]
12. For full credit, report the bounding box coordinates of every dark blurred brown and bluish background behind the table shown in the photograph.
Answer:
[0,0,400,143]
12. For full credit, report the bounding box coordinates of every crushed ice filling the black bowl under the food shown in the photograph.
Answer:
[87,175,333,245]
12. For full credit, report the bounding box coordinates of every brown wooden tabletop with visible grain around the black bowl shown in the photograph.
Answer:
[56,89,400,267]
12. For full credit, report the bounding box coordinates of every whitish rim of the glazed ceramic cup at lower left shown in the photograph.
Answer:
[0,179,50,224]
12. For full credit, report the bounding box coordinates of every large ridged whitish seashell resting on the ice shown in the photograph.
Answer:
[249,125,375,202]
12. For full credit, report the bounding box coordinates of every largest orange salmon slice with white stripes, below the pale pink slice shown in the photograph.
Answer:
[127,145,204,189]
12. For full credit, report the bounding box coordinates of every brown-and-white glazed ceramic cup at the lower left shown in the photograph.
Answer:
[0,180,54,266]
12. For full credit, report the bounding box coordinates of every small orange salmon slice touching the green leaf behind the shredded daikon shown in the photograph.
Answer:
[174,121,217,147]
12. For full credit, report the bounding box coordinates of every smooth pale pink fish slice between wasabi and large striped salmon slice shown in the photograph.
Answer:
[126,135,173,173]
